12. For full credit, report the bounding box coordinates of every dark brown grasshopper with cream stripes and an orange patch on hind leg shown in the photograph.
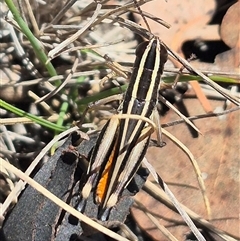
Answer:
[77,2,209,241]
